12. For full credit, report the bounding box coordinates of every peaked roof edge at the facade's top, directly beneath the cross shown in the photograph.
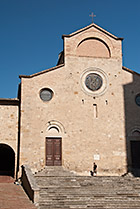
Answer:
[62,23,123,40]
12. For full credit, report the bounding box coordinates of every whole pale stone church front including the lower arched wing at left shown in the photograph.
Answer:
[0,23,140,176]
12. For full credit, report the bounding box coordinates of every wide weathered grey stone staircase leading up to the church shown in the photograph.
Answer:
[34,167,140,209]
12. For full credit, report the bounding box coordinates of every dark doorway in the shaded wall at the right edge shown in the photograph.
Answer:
[131,141,140,169]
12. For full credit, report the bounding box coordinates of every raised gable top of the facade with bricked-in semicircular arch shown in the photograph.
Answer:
[63,23,123,59]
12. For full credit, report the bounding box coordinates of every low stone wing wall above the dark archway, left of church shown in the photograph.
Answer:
[0,99,18,174]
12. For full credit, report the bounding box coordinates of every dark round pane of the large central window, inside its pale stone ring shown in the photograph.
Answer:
[85,73,103,91]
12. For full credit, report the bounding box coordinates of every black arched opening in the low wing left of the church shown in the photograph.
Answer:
[0,144,15,177]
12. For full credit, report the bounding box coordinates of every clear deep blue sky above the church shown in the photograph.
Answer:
[0,0,140,98]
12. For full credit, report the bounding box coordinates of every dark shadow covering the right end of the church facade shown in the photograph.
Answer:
[123,70,140,177]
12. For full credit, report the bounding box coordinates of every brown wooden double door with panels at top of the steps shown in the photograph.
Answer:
[46,138,62,166]
